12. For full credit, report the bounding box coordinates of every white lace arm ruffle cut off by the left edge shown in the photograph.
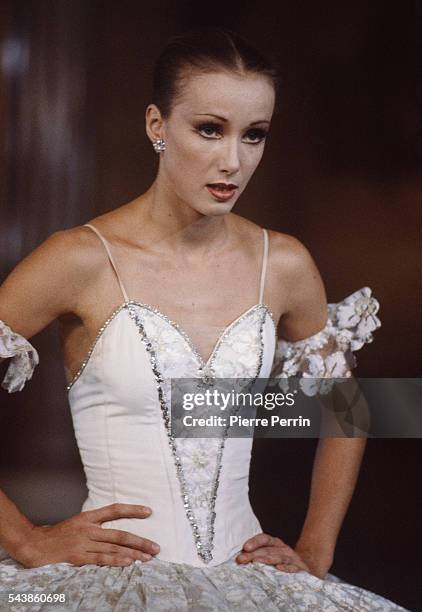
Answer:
[0,320,39,393]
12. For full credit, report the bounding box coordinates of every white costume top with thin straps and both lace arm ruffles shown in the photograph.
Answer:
[0,216,380,567]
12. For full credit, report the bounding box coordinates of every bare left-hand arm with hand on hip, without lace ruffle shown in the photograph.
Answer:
[0,228,158,567]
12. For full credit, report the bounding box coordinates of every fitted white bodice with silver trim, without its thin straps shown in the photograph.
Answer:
[69,301,276,566]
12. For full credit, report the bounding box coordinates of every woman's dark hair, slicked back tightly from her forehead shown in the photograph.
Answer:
[152,26,278,118]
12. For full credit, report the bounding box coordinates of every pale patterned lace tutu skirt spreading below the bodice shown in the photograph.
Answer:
[0,557,405,612]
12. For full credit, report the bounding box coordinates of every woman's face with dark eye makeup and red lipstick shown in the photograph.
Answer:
[147,71,275,215]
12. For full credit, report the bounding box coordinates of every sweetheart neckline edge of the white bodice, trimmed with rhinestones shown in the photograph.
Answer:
[66,300,277,392]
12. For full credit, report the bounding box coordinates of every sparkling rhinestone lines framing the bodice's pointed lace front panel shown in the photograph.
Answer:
[127,302,267,563]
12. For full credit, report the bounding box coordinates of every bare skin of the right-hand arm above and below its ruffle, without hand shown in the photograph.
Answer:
[281,238,366,577]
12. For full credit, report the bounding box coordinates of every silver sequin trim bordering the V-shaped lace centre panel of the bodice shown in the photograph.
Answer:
[128,302,267,563]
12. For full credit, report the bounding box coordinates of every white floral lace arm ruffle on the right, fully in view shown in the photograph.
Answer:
[271,287,381,396]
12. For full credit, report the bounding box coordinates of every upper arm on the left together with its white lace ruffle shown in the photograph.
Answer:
[0,228,95,393]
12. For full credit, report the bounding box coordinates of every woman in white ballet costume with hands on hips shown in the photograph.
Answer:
[0,28,403,611]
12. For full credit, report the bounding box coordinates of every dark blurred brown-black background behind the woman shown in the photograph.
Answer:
[0,0,422,610]
